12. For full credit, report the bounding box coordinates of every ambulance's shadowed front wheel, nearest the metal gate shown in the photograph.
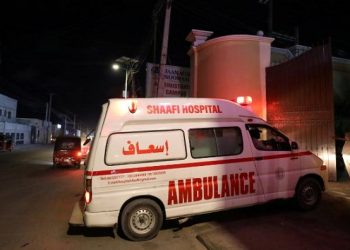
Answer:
[296,178,322,211]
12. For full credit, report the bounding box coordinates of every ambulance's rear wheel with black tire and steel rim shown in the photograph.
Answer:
[121,199,163,241]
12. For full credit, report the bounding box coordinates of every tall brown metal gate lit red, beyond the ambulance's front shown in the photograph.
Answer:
[266,44,337,181]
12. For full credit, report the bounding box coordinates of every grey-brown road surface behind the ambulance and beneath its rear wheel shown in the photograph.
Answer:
[0,146,205,250]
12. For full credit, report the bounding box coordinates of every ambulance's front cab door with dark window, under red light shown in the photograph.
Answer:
[246,124,300,200]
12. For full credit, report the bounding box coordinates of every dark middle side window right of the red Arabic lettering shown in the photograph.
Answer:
[189,127,243,158]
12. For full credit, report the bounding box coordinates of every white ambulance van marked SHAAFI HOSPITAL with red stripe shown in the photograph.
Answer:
[69,98,327,240]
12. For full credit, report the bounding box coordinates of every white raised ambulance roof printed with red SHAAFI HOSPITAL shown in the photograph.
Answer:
[102,98,260,135]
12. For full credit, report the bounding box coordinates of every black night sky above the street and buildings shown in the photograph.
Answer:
[0,0,350,127]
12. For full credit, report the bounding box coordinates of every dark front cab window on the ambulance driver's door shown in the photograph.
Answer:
[247,124,291,151]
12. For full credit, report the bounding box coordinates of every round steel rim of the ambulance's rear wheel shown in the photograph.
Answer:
[130,208,156,234]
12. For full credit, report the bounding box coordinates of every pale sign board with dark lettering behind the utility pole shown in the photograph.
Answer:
[146,63,190,97]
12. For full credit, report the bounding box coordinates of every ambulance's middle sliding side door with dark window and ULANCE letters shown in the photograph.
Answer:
[189,123,262,209]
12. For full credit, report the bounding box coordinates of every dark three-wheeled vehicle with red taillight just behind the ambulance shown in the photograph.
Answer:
[53,136,81,167]
